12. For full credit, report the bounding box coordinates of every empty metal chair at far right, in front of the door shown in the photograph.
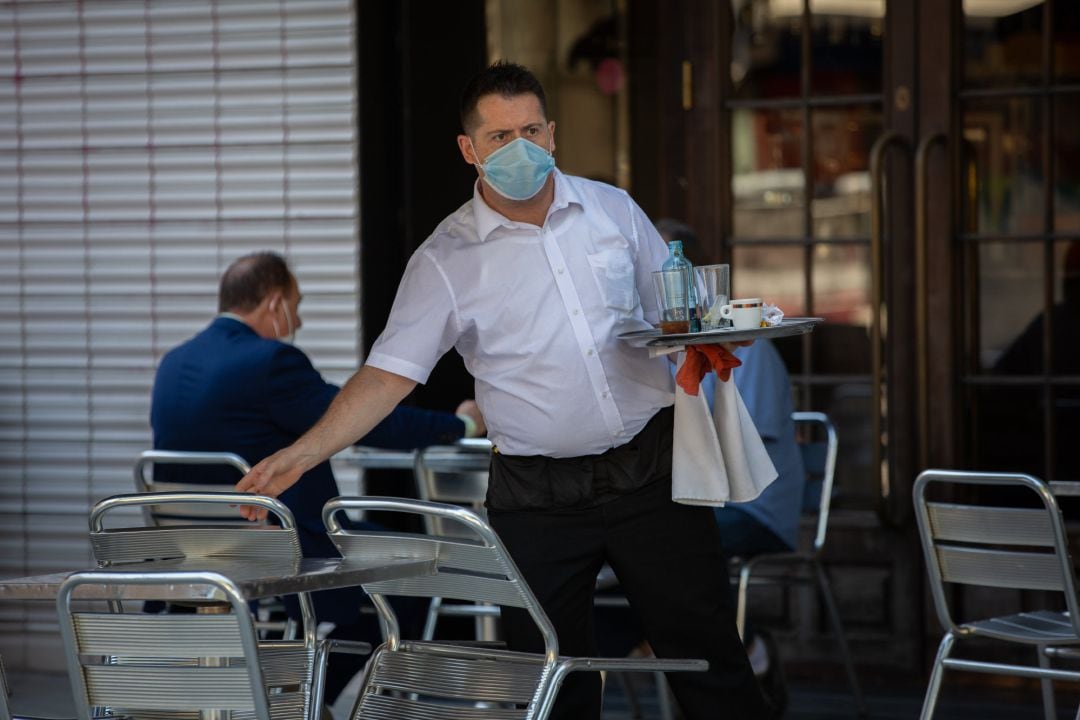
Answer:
[914,470,1080,720]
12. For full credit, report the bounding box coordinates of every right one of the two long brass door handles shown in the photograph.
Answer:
[915,133,947,472]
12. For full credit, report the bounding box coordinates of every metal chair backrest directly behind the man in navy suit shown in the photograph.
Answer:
[135,450,252,526]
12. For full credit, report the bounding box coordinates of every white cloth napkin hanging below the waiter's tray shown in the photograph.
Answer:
[672,353,777,505]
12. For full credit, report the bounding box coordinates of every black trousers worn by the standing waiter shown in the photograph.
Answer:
[488,408,768,720]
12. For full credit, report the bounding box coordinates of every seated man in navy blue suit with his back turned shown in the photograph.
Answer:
[150,253,486,703]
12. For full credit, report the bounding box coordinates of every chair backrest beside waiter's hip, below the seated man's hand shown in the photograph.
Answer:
[413,440,491,535]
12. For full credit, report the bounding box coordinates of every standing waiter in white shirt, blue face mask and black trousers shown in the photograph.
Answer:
[238,63,768,720]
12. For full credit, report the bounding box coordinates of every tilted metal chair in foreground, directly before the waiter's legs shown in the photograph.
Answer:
[323,498,707,720]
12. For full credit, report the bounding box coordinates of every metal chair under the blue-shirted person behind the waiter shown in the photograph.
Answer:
[732,412,866,716]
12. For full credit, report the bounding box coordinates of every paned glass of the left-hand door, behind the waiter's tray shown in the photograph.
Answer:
[724,0,888,518]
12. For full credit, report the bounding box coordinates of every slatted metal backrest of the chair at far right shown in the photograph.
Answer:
[914,470,1080,635]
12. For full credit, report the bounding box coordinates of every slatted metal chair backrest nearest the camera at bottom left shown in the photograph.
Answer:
[56,570,300,720]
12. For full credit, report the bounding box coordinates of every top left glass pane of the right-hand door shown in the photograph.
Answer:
[963,0,1045,87]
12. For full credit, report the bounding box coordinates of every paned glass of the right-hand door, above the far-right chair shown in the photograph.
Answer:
[956,0,1080,479]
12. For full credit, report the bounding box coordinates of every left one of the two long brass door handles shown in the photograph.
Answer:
[870,131,908,527]
